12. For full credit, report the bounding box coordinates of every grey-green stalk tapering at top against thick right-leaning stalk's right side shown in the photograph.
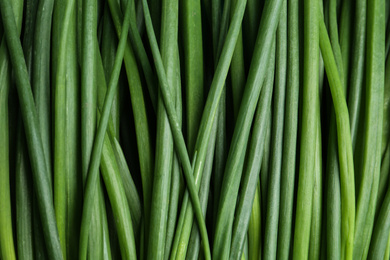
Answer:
[263,1,287,259]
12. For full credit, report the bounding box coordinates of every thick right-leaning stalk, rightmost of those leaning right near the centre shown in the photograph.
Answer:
[213,1,283,258]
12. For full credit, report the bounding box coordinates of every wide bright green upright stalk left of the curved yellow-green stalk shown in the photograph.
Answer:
[293,0,320,260]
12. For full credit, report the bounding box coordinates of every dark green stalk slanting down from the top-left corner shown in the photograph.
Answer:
[0,0,62,259]
